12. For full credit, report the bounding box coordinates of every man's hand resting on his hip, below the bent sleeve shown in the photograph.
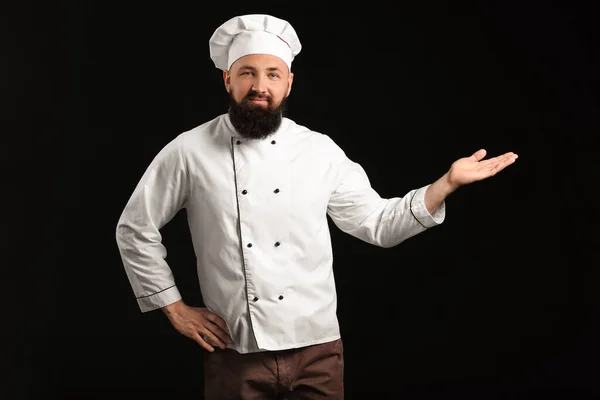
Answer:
[163,301,231,352]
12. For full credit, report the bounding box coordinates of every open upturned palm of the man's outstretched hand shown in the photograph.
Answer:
[448,149,518,188]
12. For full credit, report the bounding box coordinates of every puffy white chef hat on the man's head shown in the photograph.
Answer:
[209,14,302,70]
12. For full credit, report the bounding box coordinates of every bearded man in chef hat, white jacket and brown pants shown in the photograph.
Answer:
[116,15,517,399]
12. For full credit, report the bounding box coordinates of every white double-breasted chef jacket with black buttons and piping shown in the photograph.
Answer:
[116,114,445,353]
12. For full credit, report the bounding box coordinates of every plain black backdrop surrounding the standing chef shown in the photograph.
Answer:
[0,1,600,399]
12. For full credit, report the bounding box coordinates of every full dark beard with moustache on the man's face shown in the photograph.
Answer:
[229,91,286,139]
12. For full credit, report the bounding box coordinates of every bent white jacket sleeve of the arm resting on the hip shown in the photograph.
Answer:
[116,137,188,312]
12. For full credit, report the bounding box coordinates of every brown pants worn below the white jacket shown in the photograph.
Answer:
[204,339,344,400]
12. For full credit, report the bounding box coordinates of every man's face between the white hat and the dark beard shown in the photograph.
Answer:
[223,54,294,110]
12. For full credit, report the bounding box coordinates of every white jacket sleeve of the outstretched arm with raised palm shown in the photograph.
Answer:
[327,139,446,247]
